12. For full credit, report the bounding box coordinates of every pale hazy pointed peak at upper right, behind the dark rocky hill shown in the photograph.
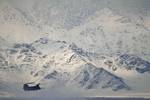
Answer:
[67,8,150,58]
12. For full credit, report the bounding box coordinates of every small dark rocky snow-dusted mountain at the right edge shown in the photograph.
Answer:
[100,54,150,74]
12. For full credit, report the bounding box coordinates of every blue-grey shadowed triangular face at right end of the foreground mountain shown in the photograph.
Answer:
[68,63,129,91]
